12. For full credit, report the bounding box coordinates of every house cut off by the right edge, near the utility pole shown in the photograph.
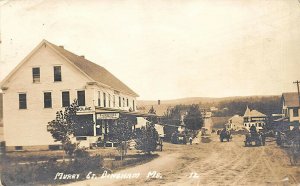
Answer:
[281,92,300,122]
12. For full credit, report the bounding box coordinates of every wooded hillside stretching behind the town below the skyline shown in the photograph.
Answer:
[138,96,281,117]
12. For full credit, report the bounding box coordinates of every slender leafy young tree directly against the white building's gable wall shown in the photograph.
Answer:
[47,100,78,156]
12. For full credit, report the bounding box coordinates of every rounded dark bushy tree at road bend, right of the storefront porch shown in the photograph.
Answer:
[136,123,158,154]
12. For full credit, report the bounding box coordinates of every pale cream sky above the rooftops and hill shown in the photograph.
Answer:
[0,0,300,100]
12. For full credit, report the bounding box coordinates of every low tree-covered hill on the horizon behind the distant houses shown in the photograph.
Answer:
[137,95,281,117]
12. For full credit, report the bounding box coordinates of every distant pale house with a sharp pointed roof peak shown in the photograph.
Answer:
[243,106,267,130]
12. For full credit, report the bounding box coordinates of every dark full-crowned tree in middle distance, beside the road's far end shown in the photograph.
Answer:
[183,104,203,131]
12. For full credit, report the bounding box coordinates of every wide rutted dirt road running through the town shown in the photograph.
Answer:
[66,134,300,185]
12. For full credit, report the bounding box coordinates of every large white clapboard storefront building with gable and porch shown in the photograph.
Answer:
[1,40,143,150]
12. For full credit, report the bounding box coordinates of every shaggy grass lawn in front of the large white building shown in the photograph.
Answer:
[0,148,158,185]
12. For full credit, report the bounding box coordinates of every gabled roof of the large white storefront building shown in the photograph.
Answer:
[1,40,139,97]
